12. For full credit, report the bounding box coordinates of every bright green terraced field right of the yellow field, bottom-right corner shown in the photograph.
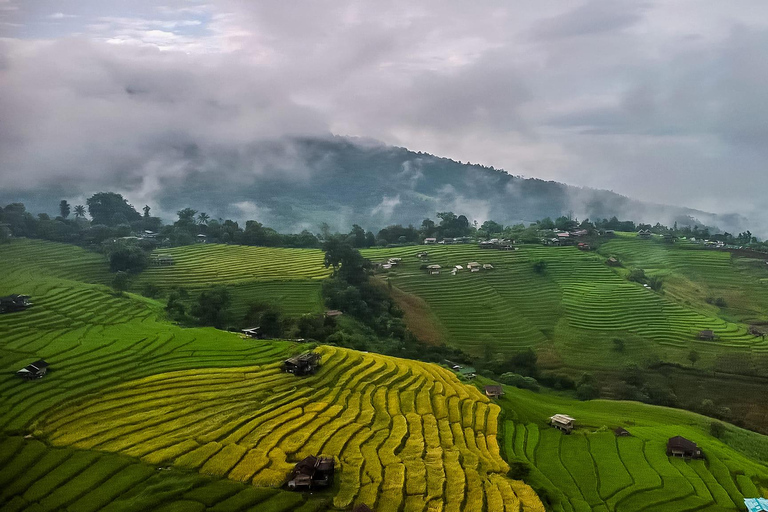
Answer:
[492,389,768,512]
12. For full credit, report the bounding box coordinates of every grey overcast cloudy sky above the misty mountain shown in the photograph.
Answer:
[0,0,768,224]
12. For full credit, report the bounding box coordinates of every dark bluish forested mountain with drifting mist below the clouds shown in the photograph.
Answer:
[0,137,748,233]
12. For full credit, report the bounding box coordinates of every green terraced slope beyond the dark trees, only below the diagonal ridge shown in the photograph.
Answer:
[364,245,768,366]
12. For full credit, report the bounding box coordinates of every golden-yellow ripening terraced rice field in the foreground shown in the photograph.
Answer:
[36,347,543,511]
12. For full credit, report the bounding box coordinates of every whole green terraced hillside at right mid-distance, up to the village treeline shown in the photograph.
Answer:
[363,237,768,369]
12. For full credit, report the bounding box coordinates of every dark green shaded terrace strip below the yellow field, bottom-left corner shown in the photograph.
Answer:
[0,437,325,512]
